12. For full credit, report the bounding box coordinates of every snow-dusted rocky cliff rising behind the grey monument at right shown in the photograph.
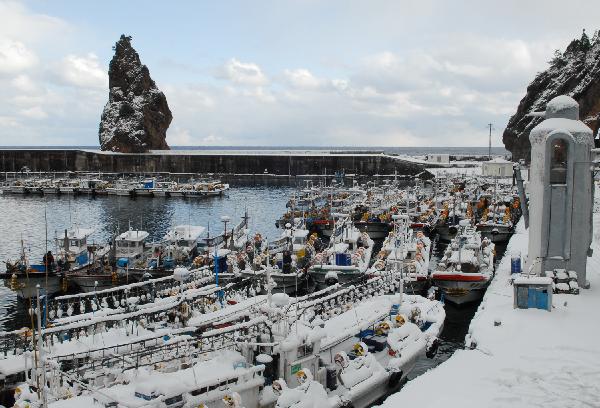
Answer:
[502,31,600,161]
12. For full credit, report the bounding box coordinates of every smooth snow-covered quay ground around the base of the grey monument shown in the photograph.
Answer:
[382,214,600,408]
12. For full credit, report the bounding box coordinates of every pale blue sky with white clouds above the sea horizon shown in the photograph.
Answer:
[0,0,600,146]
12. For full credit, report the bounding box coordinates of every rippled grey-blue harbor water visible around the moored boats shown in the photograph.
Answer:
[0,186,502,396]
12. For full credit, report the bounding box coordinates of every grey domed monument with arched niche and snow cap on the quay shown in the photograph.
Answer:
[526,95,594,287]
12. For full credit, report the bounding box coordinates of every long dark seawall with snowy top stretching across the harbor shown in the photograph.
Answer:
[0,149,433,176]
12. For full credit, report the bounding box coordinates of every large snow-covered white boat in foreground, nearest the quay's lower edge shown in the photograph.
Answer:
[270,280,445,408]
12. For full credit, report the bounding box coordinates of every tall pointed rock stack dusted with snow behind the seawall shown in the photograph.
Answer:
[99,35,173,153]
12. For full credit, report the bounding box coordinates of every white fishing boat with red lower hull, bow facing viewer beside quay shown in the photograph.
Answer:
[432,220,495,304]
